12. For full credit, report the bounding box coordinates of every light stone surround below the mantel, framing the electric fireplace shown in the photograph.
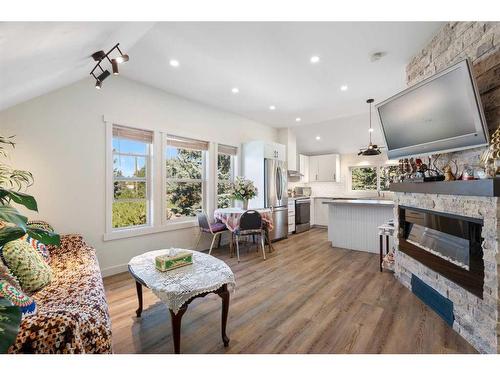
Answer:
[394,193,500,353]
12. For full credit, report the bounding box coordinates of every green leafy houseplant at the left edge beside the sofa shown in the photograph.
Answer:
[0,136,60,353]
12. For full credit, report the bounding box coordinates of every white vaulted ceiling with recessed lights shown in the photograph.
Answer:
[0,22,442,152]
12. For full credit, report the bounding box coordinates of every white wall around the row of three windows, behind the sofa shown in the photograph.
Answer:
[0,77,277,275]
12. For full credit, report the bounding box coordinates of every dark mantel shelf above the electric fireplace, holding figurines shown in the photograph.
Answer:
[390,178,500,197]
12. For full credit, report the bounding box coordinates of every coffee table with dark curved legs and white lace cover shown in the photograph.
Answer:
[128,249,236,354]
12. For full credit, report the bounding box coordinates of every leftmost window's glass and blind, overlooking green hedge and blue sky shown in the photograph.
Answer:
[111,125,153,229]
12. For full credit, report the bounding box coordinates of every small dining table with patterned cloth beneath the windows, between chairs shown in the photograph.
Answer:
[214,207,274,256]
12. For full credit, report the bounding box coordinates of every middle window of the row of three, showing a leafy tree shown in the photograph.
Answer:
[165,135,208,220]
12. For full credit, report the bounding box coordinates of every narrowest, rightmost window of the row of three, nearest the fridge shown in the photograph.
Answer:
[217,145,238,208]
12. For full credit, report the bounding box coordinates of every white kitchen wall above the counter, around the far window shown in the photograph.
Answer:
[288,153,394,197]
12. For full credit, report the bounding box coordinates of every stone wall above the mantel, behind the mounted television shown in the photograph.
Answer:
[406,22,500,175]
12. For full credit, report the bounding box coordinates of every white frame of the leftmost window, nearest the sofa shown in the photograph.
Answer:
[104,121,156,240]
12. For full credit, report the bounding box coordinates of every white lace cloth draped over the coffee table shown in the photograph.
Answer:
[129,249,236,314]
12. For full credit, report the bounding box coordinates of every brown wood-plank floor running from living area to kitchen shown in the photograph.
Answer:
[104,229,476,354]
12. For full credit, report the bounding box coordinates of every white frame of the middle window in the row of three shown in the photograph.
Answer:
[160,132,212,225]
